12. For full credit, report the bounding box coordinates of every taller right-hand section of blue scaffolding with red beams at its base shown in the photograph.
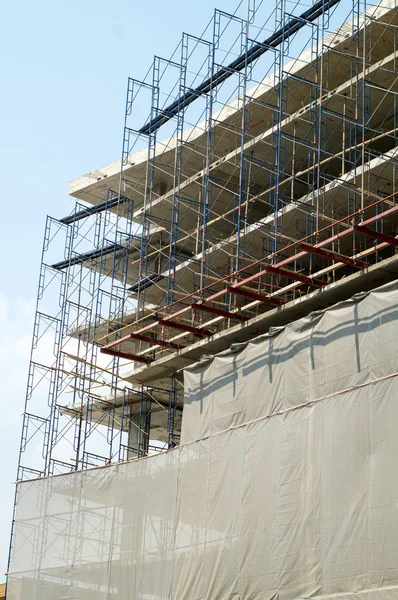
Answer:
[102,2,396,364]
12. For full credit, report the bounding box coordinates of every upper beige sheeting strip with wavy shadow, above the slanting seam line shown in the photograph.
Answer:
[181,281,398,443]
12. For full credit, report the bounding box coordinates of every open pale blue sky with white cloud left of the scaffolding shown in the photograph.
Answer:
[0,0,234,582]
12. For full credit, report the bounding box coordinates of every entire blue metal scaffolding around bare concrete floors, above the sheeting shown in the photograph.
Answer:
[7,0,398,556]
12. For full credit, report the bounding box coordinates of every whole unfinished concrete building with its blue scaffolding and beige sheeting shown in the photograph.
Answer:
[6,0,398,600]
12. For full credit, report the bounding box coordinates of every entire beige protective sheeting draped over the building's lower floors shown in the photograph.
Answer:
[7,285,398,600]
